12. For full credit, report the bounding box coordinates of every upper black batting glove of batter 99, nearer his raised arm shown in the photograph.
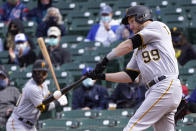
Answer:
[94,56,109,74]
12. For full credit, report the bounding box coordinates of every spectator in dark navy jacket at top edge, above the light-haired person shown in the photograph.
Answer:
[27,0,52,25]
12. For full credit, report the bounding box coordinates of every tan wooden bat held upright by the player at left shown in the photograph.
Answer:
[37,37,60,90]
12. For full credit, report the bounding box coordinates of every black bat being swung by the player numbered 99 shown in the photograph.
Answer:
[42,76,87,105]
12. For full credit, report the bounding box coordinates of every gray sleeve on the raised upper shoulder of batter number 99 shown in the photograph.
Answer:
[138,26,161,45]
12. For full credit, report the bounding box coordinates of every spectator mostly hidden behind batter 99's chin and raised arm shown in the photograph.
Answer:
[116,25,134,40]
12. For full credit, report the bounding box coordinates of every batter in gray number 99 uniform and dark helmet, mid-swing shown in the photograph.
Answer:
[86,5,182,131]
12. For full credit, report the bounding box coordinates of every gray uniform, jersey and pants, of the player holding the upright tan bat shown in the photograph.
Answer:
[6,79,55,131]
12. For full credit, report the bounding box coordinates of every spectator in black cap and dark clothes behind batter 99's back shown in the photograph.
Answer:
[171,27,196,65]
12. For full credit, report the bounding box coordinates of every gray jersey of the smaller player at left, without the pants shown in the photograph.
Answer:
[14,79,49,122]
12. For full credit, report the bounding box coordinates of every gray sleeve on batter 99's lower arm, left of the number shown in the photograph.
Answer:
[126,49,140,73]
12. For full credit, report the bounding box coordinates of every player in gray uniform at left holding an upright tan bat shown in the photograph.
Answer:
[6,60,67,131]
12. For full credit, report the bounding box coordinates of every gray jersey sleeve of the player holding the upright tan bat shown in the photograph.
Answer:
[28,88,44,107]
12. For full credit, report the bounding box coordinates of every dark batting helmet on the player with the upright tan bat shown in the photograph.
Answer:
[33,59,48,71]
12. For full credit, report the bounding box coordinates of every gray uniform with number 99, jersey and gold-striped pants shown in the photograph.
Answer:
[123,21,182,131]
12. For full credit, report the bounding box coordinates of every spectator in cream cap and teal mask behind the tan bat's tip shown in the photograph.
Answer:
[39,26,71,67]
